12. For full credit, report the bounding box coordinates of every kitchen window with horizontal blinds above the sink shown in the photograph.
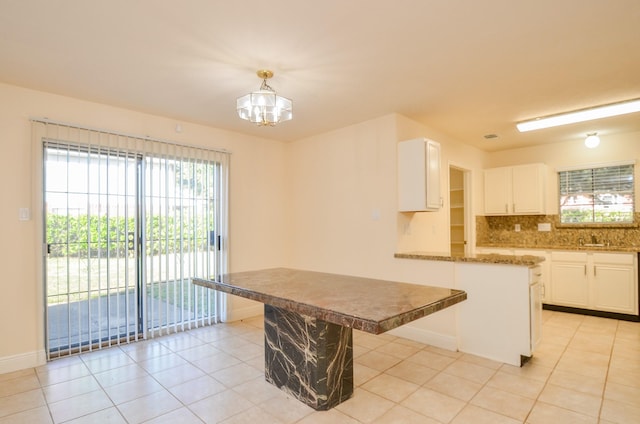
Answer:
[558,163,634,224]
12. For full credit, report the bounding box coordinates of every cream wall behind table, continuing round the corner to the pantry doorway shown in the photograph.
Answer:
[288,115,485,348]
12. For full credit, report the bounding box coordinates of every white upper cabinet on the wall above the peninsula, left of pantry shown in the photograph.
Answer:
[398,138,442,212]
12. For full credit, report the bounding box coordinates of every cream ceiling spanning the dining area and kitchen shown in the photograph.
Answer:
[0,0,640,151]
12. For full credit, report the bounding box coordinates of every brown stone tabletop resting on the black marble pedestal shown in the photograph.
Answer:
[193,268,467,334]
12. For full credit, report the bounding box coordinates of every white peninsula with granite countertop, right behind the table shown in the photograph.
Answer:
[392,252,545,366]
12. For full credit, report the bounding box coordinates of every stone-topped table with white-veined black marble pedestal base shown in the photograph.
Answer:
[193,268,467,410]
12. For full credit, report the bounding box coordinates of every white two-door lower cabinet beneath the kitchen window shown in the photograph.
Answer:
[545,251,638,315]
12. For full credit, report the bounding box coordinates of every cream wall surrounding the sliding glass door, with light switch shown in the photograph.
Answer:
[0,84,288,373]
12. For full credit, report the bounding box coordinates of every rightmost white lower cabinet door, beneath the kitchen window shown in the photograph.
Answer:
[593,263,638,314]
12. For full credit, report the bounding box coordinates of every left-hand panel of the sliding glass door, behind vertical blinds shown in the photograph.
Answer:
[44,142,142,353]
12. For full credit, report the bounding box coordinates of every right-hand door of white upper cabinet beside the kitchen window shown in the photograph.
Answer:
[511,164,545,215]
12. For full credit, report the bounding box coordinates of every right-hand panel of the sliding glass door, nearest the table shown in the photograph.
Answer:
[141,157,221,334]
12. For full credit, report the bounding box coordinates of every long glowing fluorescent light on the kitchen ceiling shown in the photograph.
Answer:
[516,99,640,132]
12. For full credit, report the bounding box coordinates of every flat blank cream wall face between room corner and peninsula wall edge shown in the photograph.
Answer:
[288,115,397,276]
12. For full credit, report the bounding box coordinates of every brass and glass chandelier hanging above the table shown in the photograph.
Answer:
[236,69,293,127]
